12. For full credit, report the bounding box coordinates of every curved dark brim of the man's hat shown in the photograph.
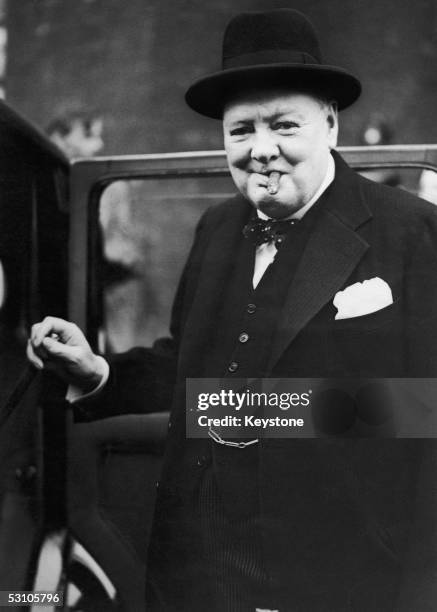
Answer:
[185,63,361,119]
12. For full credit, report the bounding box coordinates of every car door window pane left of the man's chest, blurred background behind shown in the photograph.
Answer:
[93,178,234,352]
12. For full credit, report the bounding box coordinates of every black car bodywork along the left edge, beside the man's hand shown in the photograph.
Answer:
[0,102,68,592]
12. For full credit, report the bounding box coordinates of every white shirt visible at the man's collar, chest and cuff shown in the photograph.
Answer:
[67,155,335,403]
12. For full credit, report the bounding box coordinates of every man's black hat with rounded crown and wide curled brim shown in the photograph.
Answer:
[185,8,361,119]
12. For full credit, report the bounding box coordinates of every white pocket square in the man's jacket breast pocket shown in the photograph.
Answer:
[333,276,393,319]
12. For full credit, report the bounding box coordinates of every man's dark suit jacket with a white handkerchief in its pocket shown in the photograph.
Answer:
[82,154,437,612]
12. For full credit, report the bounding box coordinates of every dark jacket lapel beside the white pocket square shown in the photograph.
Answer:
[268,153,371,372]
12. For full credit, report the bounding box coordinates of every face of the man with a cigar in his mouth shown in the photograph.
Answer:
[223,90,338,219]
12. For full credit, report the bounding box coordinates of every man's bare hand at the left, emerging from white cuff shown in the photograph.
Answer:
[27,317,103,393]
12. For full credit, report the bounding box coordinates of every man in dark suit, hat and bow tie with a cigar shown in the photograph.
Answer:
[28,9,437,612]
